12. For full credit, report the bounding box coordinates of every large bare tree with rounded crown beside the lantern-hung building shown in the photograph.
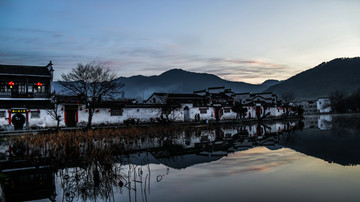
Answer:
[60,62,124,128]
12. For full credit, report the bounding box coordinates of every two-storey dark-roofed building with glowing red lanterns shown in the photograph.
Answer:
[0,61,54,129]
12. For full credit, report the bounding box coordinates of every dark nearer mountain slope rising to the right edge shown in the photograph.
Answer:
[265,57,360,100]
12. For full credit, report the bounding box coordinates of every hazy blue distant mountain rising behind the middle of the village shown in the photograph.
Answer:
[118,69,279,99]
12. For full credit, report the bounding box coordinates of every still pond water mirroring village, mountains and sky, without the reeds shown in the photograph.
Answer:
[1,115,360,202]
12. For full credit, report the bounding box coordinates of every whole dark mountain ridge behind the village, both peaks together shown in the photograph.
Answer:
[54,57,360,100]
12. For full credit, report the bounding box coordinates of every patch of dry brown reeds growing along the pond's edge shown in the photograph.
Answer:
[3,125,208,165]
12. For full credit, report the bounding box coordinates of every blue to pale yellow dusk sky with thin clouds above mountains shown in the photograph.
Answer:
[0,0,360,84]
